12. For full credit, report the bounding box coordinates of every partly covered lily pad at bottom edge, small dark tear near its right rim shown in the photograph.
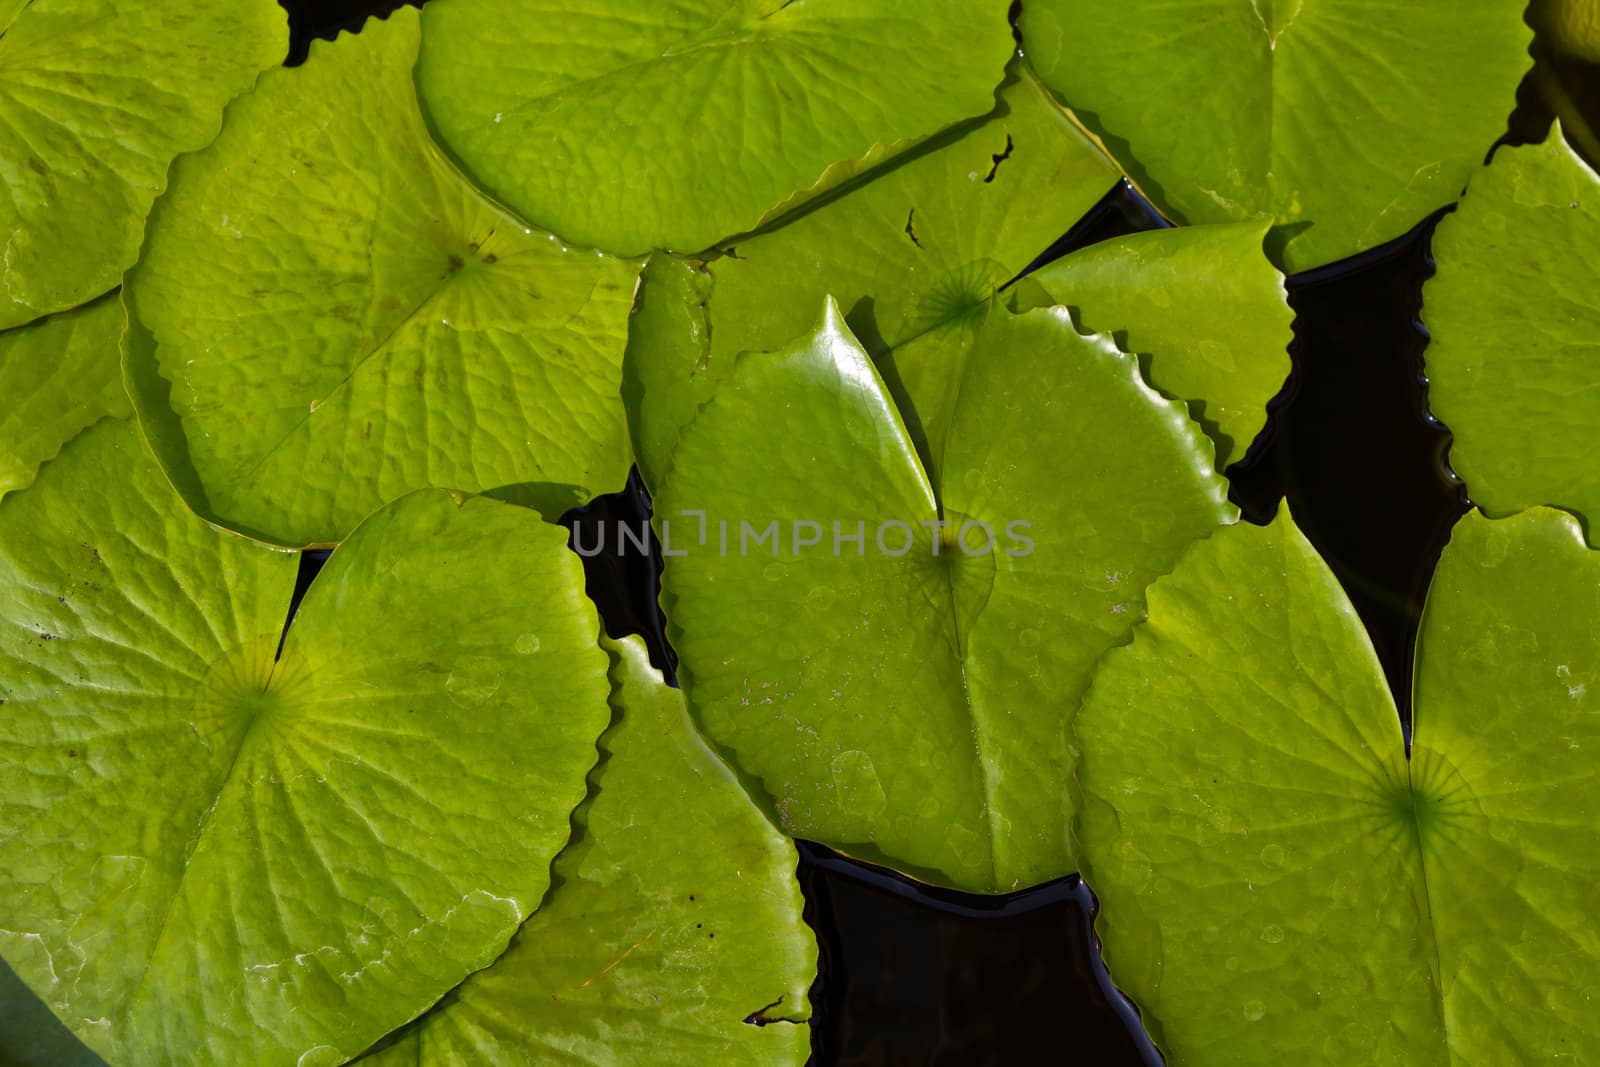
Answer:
[365,637,816,1067]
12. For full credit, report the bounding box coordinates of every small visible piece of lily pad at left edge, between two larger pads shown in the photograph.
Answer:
[0,294,128,499]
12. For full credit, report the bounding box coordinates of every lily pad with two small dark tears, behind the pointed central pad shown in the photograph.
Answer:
[626,62,1290,483]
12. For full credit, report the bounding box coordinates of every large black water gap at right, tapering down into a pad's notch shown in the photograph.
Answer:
[1227,214,1469,736]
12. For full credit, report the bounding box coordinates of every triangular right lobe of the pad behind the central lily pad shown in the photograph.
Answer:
[1029,221,1294,470]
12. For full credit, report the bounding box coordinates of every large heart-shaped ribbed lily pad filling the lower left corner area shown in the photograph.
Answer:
[0,421,608,1067]
